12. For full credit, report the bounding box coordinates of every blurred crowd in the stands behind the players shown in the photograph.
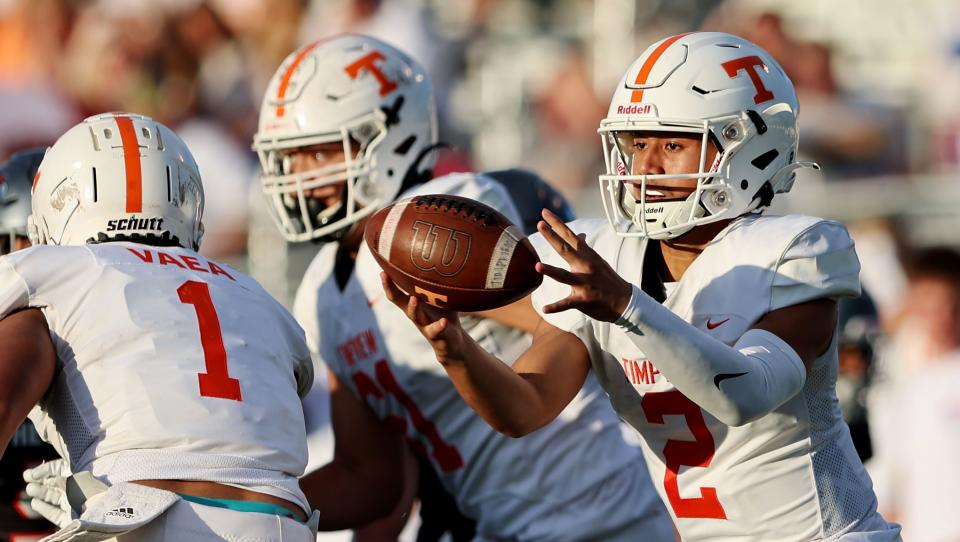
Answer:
[0,0,960,540]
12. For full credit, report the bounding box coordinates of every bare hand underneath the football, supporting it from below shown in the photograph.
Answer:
[380,272,467,364]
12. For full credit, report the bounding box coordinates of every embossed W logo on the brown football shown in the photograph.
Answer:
[410,220,472,277]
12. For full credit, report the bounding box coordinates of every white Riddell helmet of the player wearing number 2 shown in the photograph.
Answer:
[598,32,818,239]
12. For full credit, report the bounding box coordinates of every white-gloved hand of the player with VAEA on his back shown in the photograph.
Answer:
[23,459,107,529]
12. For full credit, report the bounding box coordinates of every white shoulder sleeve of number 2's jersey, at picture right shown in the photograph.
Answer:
[769,220,860,311]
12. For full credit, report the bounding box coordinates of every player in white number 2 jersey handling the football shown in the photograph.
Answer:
[383,32,900,541]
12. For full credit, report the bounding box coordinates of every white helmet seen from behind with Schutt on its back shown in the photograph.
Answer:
[29,113,203,250]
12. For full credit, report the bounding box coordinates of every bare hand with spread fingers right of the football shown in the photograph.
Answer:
[537,209,633,322]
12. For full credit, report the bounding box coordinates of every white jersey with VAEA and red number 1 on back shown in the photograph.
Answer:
[0,243,313,510]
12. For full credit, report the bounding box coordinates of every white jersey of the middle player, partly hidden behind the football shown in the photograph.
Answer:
[294,176,672,541]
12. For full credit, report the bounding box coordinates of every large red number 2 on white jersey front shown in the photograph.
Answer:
[640,390,727,519]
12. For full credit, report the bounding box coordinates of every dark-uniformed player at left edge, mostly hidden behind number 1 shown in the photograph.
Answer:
[0,148,57,542]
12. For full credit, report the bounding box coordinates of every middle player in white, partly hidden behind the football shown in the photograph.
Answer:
[254,35,674,541]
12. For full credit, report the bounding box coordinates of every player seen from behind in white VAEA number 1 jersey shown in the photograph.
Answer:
[0,113,399,541]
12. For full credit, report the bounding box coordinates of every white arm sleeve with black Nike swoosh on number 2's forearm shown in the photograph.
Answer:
[616,287,806,425]
